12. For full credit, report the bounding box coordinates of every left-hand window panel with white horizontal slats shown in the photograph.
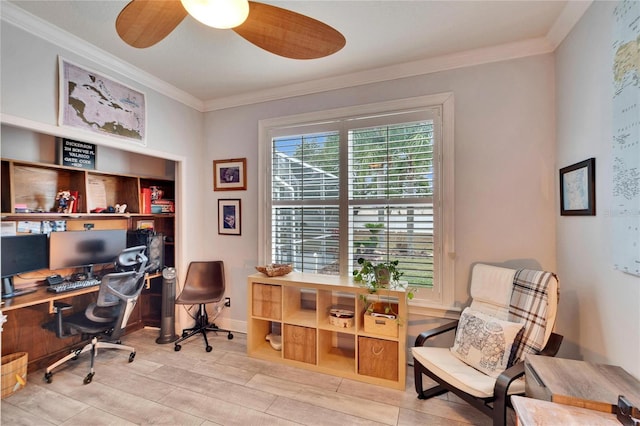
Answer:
[271,132,340,274]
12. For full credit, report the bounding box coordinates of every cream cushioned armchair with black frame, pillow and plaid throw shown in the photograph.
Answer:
[412,264,562,425]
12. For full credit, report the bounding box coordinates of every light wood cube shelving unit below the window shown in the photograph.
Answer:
[247,273,408,389]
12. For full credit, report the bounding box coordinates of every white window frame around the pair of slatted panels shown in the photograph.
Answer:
[258,92,455,314]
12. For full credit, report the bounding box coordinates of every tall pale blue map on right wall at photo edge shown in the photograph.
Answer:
[611,0,640,276]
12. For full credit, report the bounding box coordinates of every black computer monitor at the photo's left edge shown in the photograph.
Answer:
[0,234,49,299]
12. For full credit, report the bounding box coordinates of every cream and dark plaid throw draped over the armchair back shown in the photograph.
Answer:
[509,269,554,363]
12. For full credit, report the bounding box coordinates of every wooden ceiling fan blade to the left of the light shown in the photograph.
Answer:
[116,0,187,48]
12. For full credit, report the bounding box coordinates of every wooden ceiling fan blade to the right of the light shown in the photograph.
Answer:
[233,1,346,59]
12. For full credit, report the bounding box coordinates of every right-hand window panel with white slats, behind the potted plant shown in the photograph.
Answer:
[348,120,434,286]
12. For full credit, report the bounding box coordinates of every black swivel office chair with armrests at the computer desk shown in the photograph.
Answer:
[44,246,147,384]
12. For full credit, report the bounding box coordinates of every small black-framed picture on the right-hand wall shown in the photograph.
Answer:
[560,158,596,216]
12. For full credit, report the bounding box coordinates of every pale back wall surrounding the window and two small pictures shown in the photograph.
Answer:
[208,55,556,330]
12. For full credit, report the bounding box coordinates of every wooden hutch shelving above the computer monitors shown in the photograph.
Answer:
[0,159,175,326]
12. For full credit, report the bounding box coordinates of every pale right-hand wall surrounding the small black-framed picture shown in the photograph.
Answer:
[556,2,640,377]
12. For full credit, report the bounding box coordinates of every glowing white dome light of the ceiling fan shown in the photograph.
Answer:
[181,0,249,29]
